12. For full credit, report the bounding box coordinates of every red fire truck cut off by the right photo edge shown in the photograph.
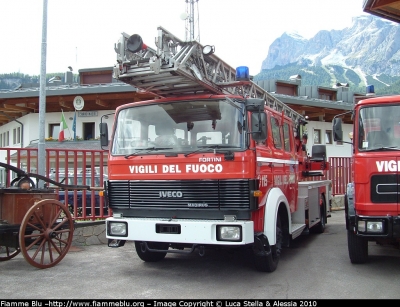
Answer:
[333,86,400,263]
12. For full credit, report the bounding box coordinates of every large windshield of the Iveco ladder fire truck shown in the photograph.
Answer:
[111,99,246,157]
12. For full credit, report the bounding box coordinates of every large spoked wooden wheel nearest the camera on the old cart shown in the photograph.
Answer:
[19,199,74,269]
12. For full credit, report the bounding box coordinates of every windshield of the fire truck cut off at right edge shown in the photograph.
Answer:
[358,105,400,151]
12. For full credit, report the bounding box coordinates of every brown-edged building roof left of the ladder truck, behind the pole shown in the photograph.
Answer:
[0,67,155,126]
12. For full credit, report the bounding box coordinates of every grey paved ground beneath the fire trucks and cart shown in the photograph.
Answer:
[0,211,400,299]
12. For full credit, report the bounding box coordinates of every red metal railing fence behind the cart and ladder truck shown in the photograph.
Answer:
[0,148,352,220]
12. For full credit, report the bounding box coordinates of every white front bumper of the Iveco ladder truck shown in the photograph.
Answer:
[106,217,254,245]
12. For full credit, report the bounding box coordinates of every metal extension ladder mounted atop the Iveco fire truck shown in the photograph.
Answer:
[113,27,305,123]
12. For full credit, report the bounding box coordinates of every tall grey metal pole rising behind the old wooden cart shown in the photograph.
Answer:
[37,0,47,188]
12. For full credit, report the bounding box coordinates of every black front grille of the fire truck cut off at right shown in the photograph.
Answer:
[371,175,400,203]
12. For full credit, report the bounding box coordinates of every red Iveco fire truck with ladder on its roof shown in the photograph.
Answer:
[100,27,331,272]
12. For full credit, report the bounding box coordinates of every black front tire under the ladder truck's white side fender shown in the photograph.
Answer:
[254,215,283,273]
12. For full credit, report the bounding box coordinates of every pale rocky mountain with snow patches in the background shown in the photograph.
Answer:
[254,15,400,90]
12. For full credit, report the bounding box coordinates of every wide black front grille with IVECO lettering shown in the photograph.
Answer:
[107,180,256,210]
